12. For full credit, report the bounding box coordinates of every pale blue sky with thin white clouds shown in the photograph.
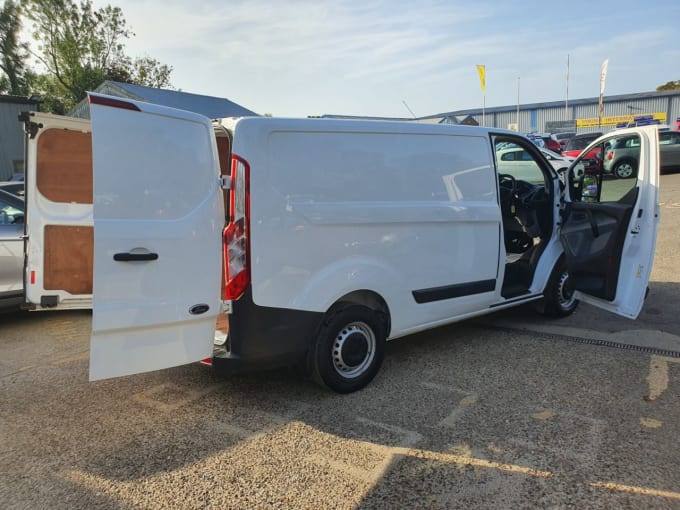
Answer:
[93,0,680,117]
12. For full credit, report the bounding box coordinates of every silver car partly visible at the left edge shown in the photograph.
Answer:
[0,189,25,307]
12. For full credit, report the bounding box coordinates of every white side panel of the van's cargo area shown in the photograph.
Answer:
[234,119,501,336]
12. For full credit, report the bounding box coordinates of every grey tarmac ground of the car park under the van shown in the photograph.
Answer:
[0,174,680,509]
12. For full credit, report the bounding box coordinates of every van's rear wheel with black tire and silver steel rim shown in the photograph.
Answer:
[308,303,387,393]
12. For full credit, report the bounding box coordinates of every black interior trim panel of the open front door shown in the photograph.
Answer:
[560,187,638,301]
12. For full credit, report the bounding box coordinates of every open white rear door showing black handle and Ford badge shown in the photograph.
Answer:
[89,94,224,380]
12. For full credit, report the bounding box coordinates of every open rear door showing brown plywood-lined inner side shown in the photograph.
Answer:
[21,113,93,309]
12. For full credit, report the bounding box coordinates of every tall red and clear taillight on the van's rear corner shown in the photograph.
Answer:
[224,155,250,300]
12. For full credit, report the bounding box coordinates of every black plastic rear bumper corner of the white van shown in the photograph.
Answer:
[213,286,324,372]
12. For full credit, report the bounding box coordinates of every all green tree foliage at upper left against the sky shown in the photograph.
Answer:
[0,0,172,113]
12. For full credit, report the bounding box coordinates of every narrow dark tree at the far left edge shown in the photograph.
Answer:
[0,1,32,96]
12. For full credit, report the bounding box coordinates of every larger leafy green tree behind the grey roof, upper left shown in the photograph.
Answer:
[24,0,172,113]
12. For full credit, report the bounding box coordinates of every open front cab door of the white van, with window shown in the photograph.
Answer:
[560,127,659,319]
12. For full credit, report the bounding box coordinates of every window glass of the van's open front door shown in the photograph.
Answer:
[569,134,640,203]
